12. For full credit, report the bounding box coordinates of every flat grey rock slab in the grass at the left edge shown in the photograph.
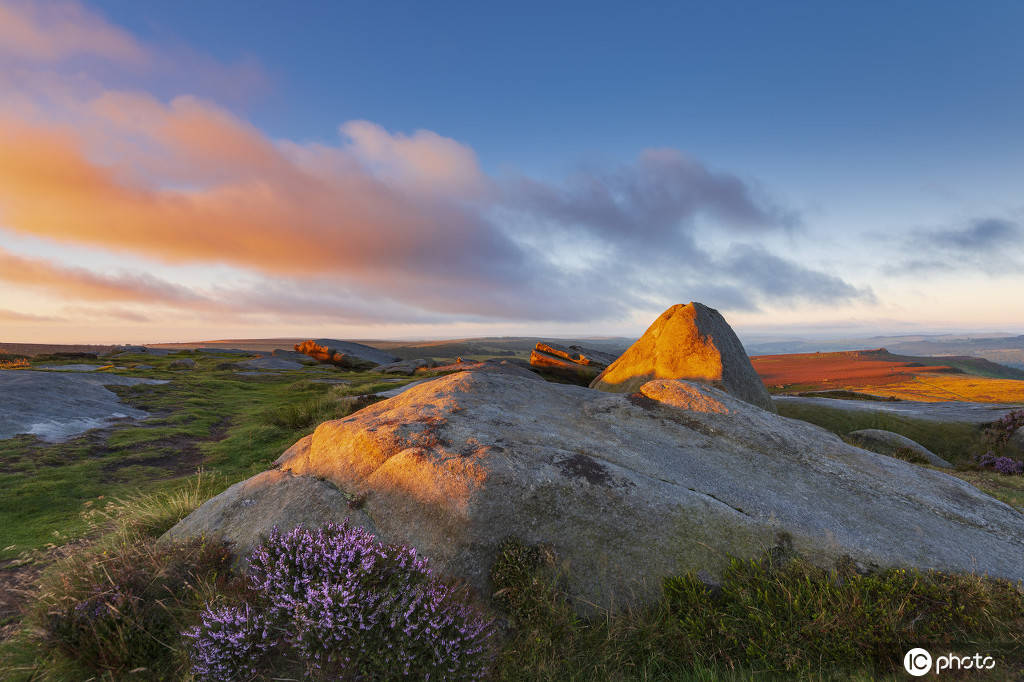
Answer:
[0,370,167,442]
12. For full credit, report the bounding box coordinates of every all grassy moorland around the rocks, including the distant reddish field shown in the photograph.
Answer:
[0,325,1024,680]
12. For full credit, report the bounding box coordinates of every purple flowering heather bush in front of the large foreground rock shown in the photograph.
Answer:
[185,522,493,680]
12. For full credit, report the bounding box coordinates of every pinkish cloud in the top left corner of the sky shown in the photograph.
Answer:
[0,0,147,63]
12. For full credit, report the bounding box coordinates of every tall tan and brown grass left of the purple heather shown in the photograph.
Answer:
[0,473,238,681]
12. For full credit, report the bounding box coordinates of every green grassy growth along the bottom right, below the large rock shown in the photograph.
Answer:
[492,541,1024,680]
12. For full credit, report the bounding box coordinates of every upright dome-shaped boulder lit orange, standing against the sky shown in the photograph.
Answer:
[590,303,775,412]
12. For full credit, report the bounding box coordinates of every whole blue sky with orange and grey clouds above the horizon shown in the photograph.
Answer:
[0,0,1024,343]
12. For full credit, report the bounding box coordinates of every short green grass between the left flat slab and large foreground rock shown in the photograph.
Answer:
[0,352,412,560]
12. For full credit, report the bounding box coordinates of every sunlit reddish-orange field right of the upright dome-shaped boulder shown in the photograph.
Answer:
[751,349,1024,402]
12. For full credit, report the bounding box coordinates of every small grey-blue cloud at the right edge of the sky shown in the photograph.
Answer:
[883,217,1024,276]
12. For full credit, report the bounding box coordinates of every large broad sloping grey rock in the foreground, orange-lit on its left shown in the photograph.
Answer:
[171,364,1024,610]
